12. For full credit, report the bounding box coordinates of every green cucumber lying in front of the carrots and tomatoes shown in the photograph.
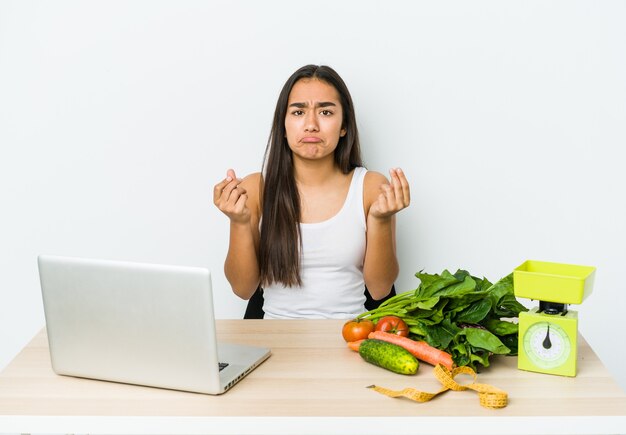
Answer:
[359,338,419,375]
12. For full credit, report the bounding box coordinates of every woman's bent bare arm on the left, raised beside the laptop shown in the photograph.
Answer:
[213,169,261,299]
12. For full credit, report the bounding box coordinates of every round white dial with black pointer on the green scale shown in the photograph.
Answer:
[523,322,572,369]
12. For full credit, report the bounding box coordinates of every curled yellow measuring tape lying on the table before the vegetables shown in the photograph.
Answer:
[367,364,509,409]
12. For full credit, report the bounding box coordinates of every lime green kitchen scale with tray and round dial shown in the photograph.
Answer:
[513,260,596,376]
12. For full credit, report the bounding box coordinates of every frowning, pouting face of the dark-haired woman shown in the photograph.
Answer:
[285,78,346,160]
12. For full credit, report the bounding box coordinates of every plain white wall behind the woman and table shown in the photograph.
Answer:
[0,0,626,387]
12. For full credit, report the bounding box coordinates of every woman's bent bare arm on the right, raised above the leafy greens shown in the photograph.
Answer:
[363,169,411,299]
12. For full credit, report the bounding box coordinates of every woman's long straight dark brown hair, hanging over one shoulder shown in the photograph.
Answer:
[259,65,363,286]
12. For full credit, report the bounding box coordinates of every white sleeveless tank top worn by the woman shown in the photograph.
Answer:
[263,167,367,319]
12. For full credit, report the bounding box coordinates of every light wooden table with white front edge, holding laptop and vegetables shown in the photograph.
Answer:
[0,320,626,434]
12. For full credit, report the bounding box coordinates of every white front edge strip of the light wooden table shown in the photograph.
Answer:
[0,415,626,435]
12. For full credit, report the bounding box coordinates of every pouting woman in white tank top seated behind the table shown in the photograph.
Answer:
[213,65,410,319]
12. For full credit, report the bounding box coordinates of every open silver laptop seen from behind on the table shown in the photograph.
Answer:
[38,255,271,394]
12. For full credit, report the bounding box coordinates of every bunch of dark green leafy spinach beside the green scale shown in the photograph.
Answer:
[355,270,527,370]
